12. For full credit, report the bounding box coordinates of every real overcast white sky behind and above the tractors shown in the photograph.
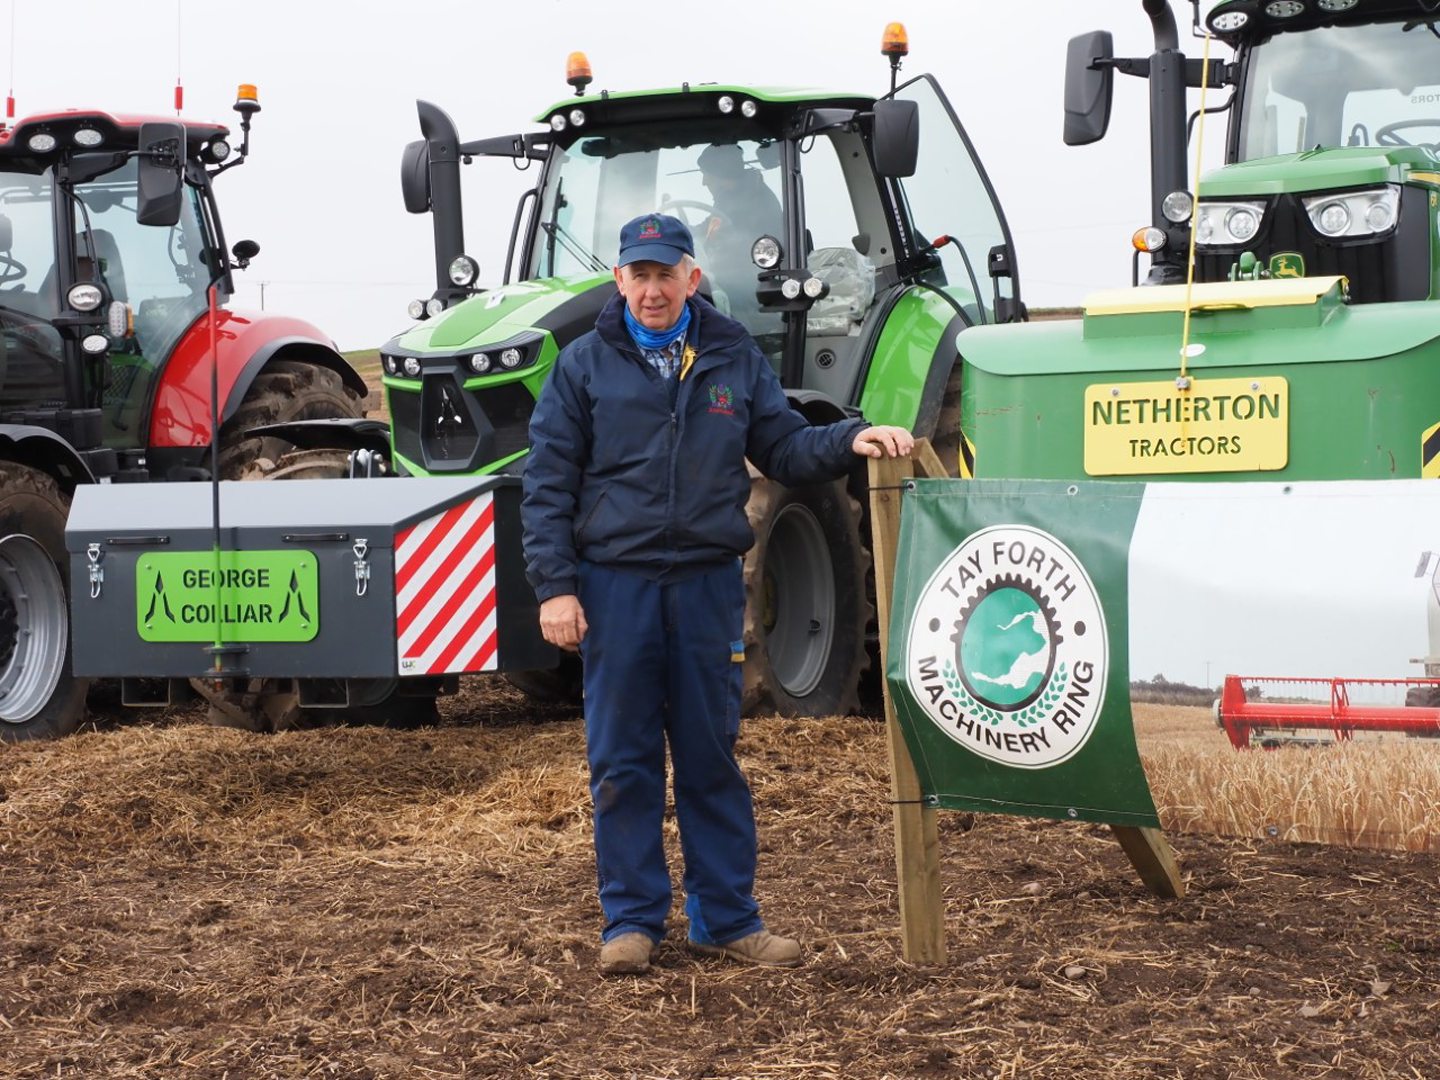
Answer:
[0,0,1223,350]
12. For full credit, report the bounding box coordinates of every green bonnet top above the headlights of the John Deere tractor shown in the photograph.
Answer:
[1200,147,1437,199]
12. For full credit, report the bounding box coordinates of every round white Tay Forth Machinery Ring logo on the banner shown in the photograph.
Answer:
[906,526,1109,769]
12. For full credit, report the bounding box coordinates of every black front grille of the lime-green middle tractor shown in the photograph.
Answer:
[390,372,536,472]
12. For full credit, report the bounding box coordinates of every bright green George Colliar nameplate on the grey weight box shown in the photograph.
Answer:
[135,552,320,642]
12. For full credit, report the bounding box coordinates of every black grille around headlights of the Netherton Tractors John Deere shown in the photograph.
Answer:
[1195,187,1430,304]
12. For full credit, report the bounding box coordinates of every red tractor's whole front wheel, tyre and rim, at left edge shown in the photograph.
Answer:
[0,461,89,742]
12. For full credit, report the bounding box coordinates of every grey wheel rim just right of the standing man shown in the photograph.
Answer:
[765,503,835,697]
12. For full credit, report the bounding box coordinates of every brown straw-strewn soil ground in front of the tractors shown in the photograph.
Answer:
[0,680,1440,1080]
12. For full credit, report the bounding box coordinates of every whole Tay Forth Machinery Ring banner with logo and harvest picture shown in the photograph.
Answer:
[886,480,1440,850]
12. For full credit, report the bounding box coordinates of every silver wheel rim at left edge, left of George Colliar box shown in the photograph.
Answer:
[0,536,69,724]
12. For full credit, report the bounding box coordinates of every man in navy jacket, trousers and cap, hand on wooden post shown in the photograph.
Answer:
[521,213,914,975]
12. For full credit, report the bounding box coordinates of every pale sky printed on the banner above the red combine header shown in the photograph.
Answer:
[1130,480,1440,685]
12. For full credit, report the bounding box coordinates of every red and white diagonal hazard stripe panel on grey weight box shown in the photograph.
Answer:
[395,492,498,675]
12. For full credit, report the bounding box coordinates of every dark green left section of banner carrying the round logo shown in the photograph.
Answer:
[886,480,1159,827]
